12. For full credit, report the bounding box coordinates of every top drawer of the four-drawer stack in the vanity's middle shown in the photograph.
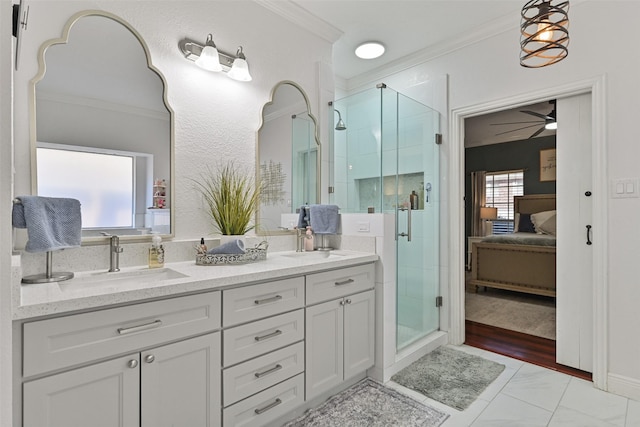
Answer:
[222,277,304,327]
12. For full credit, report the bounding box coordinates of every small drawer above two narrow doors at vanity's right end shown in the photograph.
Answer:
[306,264,375,305]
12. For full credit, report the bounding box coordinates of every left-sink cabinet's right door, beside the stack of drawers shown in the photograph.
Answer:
[141,332,221,427]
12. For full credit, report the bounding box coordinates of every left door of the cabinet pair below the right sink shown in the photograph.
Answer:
[305,299,344,400]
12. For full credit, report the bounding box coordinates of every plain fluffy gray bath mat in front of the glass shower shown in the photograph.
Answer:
[391,347,504,411]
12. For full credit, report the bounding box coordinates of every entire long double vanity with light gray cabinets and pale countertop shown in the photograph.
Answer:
[14,250,378,427]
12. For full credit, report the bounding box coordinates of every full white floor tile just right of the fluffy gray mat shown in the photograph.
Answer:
[502,363,571,411]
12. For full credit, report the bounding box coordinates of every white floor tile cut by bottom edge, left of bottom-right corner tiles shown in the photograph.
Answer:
[471,394,552,427]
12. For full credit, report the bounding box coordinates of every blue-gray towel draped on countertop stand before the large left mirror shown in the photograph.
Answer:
[11,196,82,252]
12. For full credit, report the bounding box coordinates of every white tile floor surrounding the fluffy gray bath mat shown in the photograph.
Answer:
[387,345,640,427]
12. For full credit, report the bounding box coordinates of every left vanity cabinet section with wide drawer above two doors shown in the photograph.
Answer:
[23,292,221,427]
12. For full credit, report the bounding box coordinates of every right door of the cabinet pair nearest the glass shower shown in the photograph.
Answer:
[344,291,375,380]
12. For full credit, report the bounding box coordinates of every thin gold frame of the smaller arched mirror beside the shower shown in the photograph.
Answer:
[255,80,322,236]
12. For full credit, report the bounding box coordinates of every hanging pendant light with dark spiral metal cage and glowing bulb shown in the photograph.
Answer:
[520,0,569,68]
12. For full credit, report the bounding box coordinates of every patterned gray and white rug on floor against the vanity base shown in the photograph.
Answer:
[284,379,449,427]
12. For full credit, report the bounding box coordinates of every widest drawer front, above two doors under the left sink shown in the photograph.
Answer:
[23,292,220,377]
